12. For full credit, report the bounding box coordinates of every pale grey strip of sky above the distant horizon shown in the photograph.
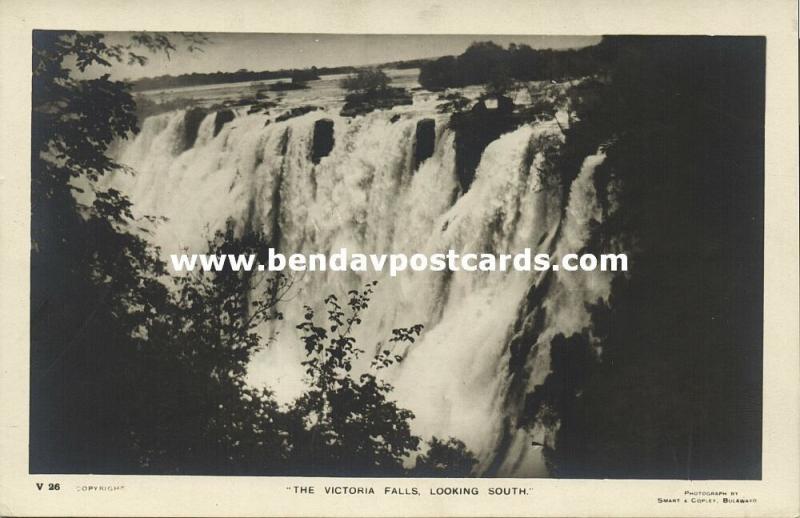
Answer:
[90,32,600,79]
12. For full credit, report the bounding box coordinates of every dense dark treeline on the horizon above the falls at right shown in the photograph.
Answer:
[419,40,613,90]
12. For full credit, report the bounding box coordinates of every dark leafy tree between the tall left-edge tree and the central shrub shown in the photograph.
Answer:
[128,229,292,474]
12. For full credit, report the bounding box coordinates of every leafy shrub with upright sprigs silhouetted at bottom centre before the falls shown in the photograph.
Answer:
[293,282,422,476]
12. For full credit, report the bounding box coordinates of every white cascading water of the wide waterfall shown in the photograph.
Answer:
[104,84,610,476]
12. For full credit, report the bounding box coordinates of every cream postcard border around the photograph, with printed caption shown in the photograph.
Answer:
[0,0,800,517]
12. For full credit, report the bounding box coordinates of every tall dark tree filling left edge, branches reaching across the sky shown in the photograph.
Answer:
[30,31,212,472]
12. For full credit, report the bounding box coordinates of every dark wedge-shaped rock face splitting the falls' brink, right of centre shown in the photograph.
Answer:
[450,95,520,192]
